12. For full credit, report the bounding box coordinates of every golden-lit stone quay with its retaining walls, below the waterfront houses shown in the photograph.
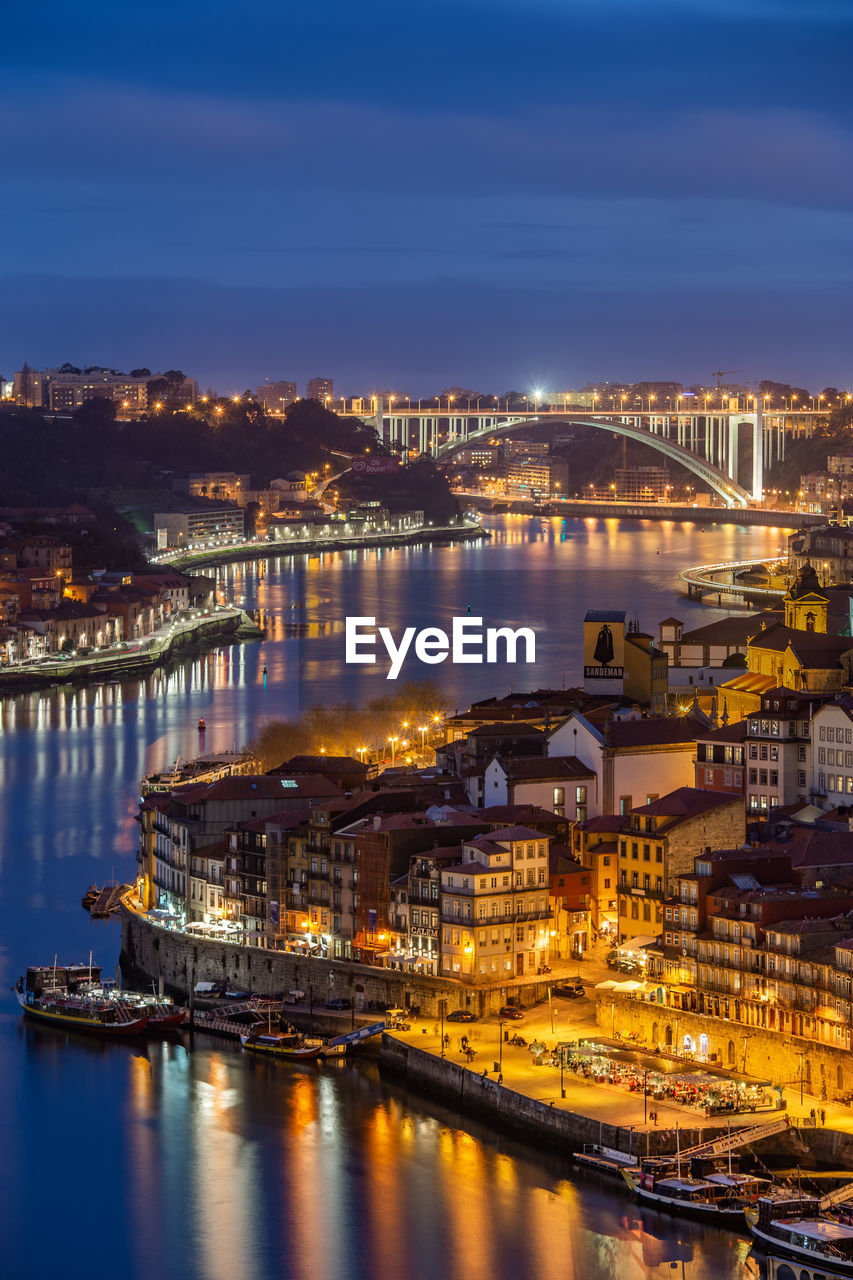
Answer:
[120,904,835,1164]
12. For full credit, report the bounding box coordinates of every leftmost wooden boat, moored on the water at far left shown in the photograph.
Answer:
[14,965,149,1037]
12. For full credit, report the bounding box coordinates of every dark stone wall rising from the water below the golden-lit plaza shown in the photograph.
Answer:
[379,1034,716,1156]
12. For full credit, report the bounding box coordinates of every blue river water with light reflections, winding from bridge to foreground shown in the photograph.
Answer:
[0,516,784,1280]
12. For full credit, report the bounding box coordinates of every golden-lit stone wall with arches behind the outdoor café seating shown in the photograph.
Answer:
[596,995,853,1102]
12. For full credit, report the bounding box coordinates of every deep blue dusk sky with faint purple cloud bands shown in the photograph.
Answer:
[0,0,853,394]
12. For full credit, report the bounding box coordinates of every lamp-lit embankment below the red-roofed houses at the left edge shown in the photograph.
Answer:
[0,605,263,696]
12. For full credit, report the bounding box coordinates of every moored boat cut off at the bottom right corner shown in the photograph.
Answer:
[745,1193,853,1276]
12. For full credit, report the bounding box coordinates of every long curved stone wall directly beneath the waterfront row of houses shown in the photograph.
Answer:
[122,909,558,1019]
